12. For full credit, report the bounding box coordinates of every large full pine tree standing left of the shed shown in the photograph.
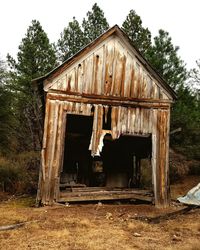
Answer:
[7,20,56,149]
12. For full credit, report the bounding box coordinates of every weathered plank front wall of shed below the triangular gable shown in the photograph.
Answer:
[37,93,170,207]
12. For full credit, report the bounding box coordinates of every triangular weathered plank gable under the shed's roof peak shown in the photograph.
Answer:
[45,36,171,100]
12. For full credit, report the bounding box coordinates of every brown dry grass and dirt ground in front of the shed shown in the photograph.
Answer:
[0,176,200,250]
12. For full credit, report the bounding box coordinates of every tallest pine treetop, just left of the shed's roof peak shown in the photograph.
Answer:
[82,3,109,43]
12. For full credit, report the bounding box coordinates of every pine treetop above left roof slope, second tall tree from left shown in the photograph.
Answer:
[57,17,86,62]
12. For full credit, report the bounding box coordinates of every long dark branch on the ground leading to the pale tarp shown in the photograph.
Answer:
[130,206,199,224]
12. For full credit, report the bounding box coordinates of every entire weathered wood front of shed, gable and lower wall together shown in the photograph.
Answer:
[37,26,175,207]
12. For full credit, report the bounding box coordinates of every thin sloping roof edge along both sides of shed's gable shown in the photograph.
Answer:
[32,25,177,99]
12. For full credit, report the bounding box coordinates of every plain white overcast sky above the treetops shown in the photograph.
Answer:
[0,0,200,69]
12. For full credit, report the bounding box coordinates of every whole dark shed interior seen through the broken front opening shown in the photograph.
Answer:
[61,115,151,188]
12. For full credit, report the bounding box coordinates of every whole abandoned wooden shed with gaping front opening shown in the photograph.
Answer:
[35,25,176,207]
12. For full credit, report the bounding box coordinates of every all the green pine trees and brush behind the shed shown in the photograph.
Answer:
[0,4,200,190]
